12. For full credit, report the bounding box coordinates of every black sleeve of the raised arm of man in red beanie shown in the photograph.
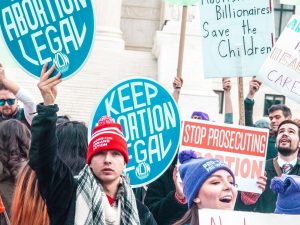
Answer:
[29,104,75,224]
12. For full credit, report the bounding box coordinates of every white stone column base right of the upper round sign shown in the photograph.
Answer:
[93,0,125,50]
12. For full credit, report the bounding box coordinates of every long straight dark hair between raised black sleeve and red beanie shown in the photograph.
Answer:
[57,121,88,175]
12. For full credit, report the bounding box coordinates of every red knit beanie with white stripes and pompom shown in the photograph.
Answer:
[87,116,129,164]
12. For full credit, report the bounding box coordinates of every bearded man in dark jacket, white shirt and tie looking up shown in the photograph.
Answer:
[235,120,300,213]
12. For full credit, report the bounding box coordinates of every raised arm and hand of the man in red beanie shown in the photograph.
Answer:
[29,64,61,186]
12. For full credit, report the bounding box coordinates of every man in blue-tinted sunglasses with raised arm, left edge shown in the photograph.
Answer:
[0,63,36,128]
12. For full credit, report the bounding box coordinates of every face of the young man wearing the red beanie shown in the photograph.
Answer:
[90,150,125,184]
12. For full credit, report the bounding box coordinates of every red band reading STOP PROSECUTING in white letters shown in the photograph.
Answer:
[181,121,268,156]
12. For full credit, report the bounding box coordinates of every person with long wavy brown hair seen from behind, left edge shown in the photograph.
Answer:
[0,119,31,219]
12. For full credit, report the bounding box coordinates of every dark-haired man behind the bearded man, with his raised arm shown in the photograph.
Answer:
[244,77,292,160]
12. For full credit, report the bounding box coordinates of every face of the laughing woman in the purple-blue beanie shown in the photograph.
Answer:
[194,170,237,210]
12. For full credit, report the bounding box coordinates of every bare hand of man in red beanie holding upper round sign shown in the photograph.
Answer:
[38,63,61,105]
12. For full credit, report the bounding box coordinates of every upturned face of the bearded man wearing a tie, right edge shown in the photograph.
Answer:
[276,123,300,156]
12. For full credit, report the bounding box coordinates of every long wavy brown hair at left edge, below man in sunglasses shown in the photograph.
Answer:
[0,119,31,180]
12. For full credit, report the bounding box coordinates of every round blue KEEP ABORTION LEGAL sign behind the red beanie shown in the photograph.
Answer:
[89,78,181,187]
